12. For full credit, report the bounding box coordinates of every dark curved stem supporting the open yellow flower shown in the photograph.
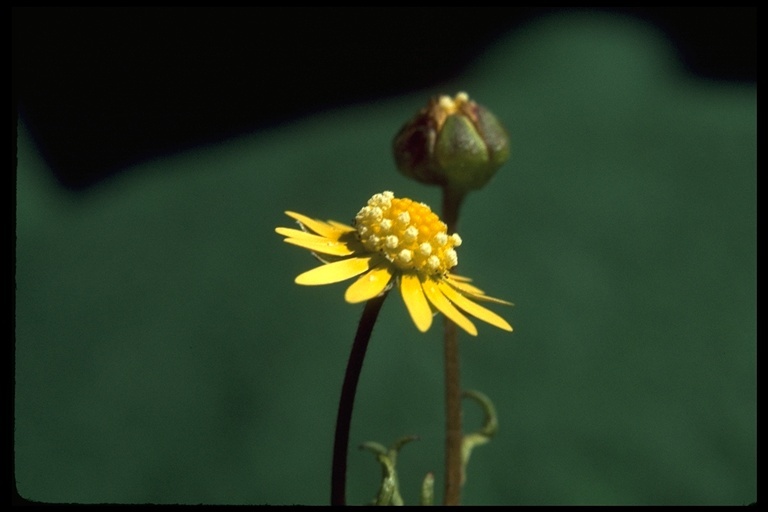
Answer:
[331,292,387,505]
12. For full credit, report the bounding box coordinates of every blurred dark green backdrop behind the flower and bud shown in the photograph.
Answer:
[14,14,757,505]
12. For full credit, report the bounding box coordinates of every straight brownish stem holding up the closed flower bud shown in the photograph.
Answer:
[443,187,464,505]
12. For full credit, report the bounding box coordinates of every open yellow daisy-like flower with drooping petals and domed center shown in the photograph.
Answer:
[275,192,512,336]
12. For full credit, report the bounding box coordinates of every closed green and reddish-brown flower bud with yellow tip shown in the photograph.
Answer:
[393,92,509,192]
